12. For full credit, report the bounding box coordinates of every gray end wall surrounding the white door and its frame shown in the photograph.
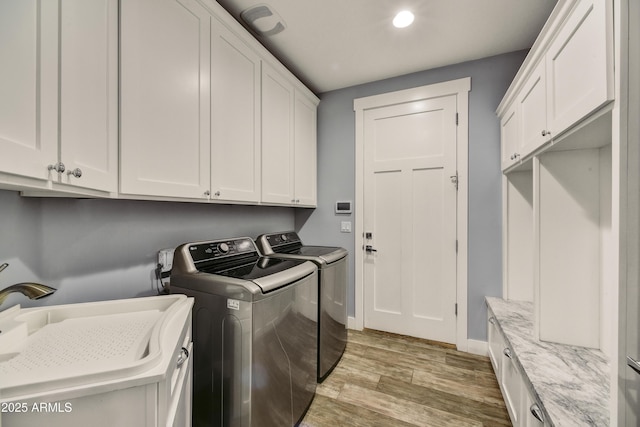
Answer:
[296,51,527,341]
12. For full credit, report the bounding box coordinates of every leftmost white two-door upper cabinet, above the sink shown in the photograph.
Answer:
[0,0,118,192]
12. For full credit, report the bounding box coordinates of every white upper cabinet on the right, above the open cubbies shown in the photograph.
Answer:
[498,0,613,170]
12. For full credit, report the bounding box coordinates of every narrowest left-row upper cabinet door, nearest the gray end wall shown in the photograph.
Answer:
[294,91,317,206]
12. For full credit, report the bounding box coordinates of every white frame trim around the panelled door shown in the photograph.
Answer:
[348,77,471,351]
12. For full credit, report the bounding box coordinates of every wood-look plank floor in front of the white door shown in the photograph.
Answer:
[300,330,511,427]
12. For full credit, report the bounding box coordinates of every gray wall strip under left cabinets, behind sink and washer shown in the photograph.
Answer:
[0,191,294,310]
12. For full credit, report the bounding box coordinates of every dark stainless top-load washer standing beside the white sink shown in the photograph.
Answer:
[170,237,318,427]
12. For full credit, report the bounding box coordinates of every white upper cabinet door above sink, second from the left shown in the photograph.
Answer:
[59,0,118,191]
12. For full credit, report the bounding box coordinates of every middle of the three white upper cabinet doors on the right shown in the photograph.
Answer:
[517,60,551,157]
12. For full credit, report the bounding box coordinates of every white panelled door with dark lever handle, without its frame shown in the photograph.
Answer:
[364,95,457,343]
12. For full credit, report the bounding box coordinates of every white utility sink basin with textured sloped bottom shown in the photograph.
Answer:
[0,295,192,399]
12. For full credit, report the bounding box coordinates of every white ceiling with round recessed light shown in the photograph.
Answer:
[217,0,556,93]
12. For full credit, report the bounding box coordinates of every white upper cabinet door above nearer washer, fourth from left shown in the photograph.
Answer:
[211,18,260,202]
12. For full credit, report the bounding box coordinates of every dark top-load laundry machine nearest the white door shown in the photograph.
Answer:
[256,231,348,382]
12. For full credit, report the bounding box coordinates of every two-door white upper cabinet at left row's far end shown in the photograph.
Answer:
[262,64,317,206]
